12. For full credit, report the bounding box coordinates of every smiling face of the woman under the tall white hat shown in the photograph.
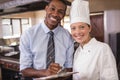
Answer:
[70,22,91,45]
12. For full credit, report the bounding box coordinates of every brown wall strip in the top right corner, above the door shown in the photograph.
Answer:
[88,0,120,12]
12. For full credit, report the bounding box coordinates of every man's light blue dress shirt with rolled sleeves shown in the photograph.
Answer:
[19,21,74,70]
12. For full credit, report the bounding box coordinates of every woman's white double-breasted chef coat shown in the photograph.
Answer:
[73,38,118,80]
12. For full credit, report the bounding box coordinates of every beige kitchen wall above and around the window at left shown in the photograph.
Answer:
[0,10,45,38]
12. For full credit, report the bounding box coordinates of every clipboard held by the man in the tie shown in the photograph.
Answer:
[36,72,78,80]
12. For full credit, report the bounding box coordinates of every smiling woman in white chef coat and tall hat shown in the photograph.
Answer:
[70,0,118,80]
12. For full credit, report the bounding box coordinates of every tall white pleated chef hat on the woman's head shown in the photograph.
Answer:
[70,0,90,25]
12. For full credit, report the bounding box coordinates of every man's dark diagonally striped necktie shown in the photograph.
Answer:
[46,31,55,68]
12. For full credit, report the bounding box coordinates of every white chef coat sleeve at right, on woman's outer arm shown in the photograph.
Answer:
[99,44,119,80]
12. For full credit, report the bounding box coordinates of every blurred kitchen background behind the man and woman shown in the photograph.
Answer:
[0,0,120,80]
